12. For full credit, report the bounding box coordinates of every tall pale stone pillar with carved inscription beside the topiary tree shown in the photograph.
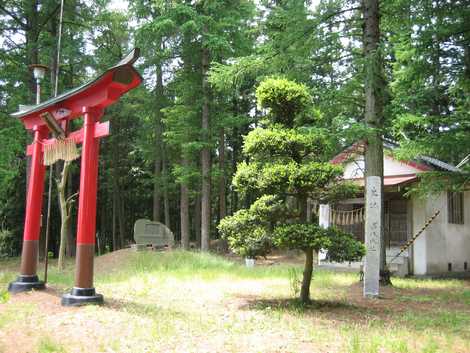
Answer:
[364,176,383,297]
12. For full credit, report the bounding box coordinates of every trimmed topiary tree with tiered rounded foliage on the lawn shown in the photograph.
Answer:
[219,78,365,303]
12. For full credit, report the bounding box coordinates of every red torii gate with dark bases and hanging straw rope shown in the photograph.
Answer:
[8,48,142,306]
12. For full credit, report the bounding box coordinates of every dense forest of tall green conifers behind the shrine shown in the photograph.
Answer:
[0,0,470,256]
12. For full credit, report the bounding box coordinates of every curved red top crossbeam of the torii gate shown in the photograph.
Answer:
[11,48,142,130]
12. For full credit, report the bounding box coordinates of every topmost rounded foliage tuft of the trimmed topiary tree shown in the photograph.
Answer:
[256,78,311,127]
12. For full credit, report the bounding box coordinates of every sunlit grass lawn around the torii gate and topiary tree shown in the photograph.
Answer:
[0,250,470,353]
